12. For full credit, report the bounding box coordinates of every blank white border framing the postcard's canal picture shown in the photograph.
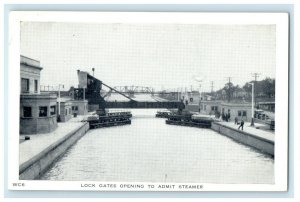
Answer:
[8,11,289,191]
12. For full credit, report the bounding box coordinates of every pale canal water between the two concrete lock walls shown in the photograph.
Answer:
[41,109,274,184]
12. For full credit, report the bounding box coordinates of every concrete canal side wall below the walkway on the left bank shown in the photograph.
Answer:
[19,123,89,180]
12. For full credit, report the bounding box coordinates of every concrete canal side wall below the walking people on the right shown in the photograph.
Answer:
[211,122,274,156]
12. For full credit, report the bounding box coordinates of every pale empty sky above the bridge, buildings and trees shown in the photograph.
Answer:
[20,22,276,91]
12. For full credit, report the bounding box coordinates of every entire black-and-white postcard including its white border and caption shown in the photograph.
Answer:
[10,12,288,191]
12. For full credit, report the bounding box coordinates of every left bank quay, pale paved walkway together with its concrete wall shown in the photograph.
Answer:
[19,116,89,180]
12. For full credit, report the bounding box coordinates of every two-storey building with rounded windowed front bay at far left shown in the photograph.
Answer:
[20,55,57,134]
